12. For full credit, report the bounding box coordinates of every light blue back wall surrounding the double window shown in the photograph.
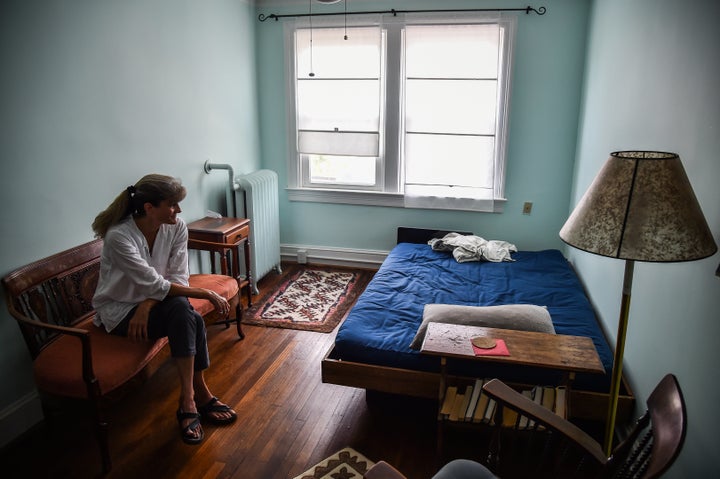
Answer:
[257,0,590,250]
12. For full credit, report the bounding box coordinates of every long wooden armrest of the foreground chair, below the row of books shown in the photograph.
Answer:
[483,379,608,464]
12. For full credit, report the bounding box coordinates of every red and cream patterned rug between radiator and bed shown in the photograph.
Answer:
[242,264,374,333]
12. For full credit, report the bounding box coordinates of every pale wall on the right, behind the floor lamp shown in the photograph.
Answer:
[568,0,720,478]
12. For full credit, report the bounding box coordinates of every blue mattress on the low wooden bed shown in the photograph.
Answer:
[334,243,612,391]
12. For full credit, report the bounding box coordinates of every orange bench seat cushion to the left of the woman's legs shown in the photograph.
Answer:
[33,319,167,398]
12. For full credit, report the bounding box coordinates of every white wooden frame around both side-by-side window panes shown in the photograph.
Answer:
[285,13,517,212]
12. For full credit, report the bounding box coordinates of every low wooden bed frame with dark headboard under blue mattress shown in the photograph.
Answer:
[321,227,635,423]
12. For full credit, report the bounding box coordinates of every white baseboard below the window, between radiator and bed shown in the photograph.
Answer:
[280,244,389,269]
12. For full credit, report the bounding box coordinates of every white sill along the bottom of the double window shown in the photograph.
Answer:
[286,188,506,213]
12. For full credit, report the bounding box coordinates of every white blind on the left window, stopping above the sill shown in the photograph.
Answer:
[296,27,382,157]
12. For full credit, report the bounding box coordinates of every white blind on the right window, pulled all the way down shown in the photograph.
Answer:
[405,19,504,210]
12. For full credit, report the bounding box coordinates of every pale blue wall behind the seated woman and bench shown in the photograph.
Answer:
[0,0,260,444]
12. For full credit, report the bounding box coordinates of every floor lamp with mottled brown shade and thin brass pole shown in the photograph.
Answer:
[560,151,717,454]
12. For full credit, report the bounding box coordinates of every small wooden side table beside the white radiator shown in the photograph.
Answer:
[188,217,252,307]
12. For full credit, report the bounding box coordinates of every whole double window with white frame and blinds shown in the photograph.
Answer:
[286,14,515,211]
